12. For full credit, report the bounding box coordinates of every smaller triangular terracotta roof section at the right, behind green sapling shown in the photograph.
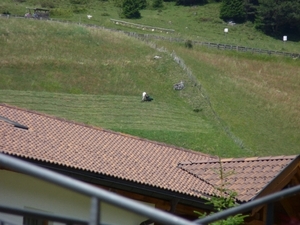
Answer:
[179,156,296,202]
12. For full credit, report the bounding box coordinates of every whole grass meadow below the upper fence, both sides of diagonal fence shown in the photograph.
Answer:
[0,0,300,157]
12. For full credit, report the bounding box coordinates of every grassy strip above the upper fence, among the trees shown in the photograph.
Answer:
[0,0,300,53]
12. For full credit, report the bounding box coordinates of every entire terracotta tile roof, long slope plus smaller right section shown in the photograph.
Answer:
[0,104,293,201]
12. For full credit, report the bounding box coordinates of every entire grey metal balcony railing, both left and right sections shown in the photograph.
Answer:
[0,153,300,225]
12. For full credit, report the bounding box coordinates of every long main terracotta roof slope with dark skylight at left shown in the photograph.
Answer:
[0,104,214,197]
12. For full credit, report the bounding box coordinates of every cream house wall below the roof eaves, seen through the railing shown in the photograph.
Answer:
[0,169,154,225]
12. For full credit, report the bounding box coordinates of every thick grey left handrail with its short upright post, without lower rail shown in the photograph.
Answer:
[0,154,196,225]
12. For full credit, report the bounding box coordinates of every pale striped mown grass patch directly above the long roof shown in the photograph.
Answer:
[0,90,244,157]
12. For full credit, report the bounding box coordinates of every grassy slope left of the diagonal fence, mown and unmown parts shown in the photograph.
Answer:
[0,19,244,156]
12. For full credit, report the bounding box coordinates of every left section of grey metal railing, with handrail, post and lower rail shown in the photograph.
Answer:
[0,153,196,225]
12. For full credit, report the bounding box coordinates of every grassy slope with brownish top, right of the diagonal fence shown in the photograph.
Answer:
[156,40,300,154]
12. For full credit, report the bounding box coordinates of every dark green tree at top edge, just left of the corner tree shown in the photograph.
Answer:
[220,0,246,22]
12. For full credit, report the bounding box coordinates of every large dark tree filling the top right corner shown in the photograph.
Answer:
[255,0,300,35]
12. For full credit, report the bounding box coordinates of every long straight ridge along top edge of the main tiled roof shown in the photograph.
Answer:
[0,103,216,159]
